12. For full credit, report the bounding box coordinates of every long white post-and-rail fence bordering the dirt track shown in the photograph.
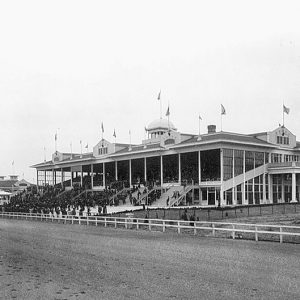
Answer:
[0,212,300,243]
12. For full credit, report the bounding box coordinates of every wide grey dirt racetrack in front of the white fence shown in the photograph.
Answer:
[0,219,300,299]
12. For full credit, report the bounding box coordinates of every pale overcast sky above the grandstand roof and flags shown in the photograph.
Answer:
[0,0,300,182]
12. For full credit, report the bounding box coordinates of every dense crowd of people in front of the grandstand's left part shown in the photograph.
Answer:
[0,180,185,215]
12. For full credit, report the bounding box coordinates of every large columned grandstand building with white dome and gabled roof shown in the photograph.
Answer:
[32,119,300,206]
